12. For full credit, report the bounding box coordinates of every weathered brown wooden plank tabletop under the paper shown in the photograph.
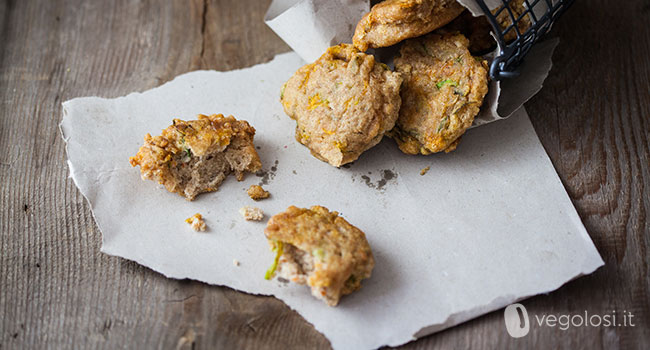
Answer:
[0,0,650,349]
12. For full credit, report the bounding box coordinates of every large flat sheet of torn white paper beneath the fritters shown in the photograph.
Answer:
[61,53,603,349]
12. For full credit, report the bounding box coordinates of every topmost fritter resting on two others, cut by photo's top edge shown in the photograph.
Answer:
[352,0,465,51]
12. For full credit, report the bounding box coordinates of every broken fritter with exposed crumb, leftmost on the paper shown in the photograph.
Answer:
[129,114,262,200]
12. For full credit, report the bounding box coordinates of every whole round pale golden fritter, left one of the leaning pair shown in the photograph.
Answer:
[280,44,402,167]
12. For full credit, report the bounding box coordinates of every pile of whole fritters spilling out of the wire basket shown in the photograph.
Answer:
[281,0,530,167]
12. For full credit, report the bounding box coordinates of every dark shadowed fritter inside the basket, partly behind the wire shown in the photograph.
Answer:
[442,0,531,55]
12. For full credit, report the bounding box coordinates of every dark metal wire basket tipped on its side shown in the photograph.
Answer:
[476,0,574,80]
